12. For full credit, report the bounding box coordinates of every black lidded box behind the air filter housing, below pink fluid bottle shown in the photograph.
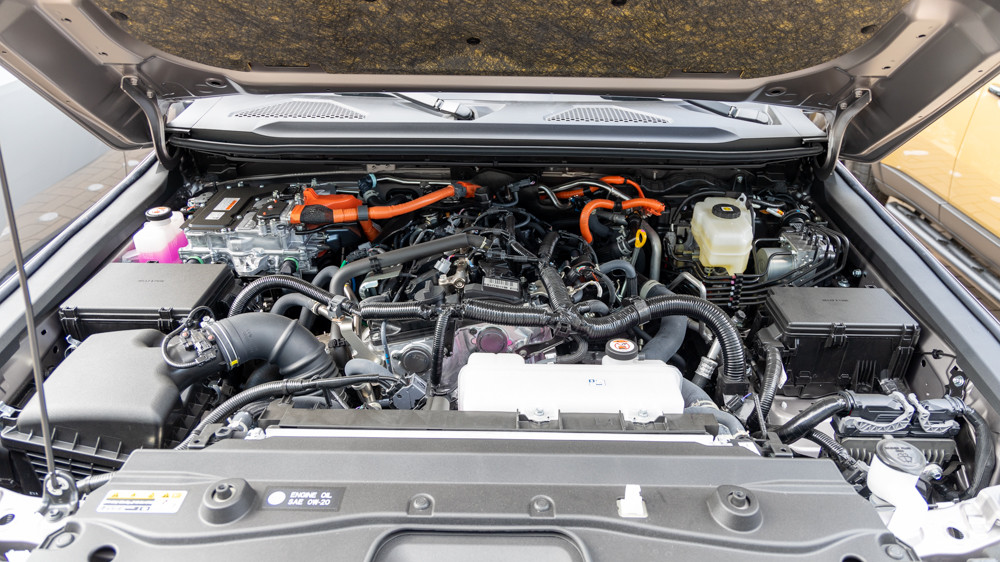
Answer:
[59,263,233,340]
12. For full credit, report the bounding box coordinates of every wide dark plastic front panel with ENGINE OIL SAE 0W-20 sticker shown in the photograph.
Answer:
[32,436,908,562]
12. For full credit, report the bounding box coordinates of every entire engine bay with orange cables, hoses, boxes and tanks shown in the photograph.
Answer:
[2,158,994,544]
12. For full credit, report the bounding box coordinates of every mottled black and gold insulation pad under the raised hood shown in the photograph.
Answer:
[96,0,907,78]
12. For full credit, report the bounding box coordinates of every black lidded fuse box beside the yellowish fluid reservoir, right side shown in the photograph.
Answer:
[759,287,920,398]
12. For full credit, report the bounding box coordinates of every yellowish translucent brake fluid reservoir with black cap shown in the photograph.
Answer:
[691,197,753,275]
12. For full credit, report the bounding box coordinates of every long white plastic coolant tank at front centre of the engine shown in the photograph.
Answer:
[458,353,684,423]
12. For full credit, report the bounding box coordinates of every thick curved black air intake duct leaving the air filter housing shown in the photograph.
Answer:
[205,312,334,378]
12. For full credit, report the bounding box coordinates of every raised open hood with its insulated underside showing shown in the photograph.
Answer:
[0,0,1000,161]
